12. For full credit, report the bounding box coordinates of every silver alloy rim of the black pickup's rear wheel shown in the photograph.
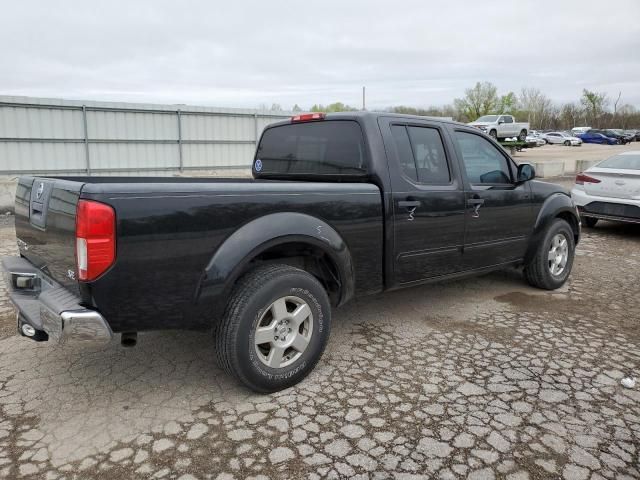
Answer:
[253,296,313,368]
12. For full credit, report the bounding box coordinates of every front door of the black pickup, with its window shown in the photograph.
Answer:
[453,129,535,270]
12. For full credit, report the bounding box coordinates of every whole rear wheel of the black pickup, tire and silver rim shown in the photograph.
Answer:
[215,265,331,393]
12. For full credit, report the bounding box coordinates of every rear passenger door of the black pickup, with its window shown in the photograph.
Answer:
[379,118,465,284]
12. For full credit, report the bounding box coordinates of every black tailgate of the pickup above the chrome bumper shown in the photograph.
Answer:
[15,177,84,293]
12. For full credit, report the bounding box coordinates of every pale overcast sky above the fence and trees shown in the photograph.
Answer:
[0,0,640,108]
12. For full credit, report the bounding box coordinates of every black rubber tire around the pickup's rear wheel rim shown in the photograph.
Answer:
[215,265,331,393]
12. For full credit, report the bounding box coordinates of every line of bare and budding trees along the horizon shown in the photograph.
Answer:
[282,82,640,130]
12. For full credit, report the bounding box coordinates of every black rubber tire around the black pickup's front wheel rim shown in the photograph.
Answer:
[524,218,575,290]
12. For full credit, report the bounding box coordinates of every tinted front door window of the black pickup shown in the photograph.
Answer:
[455,131,513,185]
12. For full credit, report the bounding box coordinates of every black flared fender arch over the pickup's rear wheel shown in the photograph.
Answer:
[198,212,355,304]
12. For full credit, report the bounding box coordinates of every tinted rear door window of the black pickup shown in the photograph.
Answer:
[391,125,451,185]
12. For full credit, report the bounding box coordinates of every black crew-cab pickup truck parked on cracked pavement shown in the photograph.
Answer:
[3,113,580,392]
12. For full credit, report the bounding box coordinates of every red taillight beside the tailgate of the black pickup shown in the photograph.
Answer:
[76,200,116,282]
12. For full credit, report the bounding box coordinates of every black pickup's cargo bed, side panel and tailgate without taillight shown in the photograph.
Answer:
[16,177,383,332]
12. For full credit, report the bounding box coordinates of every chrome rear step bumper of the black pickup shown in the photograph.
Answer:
[2,257,113,343]
